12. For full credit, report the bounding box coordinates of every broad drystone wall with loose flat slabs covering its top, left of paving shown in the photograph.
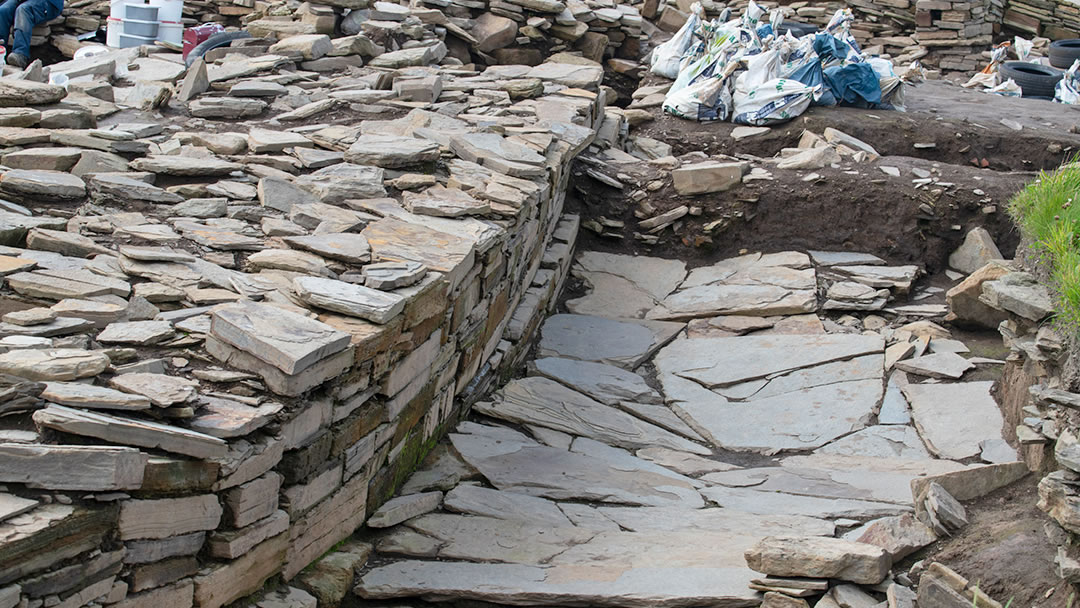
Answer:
[0,27,605,608]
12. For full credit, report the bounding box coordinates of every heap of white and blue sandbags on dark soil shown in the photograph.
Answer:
[651,0,904,125]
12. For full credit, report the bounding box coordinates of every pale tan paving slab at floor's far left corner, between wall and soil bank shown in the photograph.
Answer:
[566,252,686,319]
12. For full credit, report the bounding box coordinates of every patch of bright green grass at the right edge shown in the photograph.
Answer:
[1009,159,1080,333]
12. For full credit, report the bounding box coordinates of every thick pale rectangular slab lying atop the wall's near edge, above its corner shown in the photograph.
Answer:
[211,302,350,375]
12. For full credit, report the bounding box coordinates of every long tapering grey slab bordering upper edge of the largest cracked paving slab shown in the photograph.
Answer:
[656,334,885,396]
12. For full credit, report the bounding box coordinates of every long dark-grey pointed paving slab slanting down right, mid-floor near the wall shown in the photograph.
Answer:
[450,433,704,509]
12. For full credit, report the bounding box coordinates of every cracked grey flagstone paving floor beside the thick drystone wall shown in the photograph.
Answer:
[355,252,1003,607]
